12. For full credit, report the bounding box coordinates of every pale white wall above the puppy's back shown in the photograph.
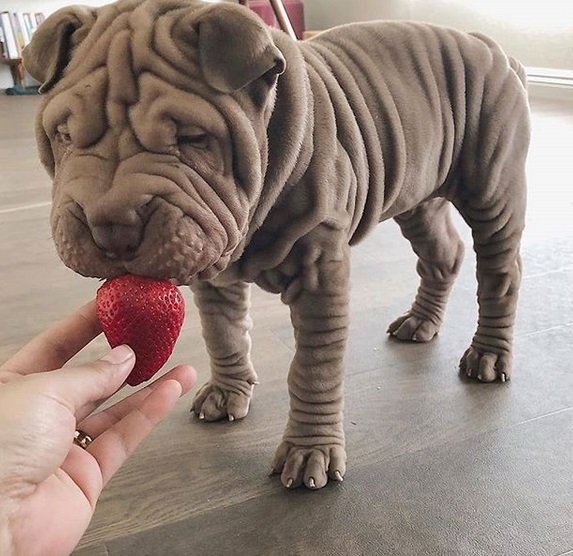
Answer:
[304,0,573,70]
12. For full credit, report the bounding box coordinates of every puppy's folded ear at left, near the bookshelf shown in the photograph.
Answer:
[22,6,96,92]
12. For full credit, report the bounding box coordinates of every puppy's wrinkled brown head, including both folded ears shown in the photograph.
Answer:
[24,0,285,284]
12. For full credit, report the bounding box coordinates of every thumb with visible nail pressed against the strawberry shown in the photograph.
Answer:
[45,345,135,414]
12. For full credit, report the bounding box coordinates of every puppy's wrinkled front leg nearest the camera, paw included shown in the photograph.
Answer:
[273,241,349,488]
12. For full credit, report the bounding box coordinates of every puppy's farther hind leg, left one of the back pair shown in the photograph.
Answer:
[388,198,464,342]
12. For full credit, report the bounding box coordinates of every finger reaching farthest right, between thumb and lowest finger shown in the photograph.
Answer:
[78,365,197,438]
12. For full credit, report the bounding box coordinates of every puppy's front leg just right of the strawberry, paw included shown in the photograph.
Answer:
[191,282,257,421]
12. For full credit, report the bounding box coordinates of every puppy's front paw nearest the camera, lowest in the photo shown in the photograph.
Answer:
[272,441,346,490]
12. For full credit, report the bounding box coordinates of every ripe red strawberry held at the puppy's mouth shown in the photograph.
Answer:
[96,274,185,386]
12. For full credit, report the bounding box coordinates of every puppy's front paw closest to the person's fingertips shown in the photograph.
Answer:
[191,381,255,421]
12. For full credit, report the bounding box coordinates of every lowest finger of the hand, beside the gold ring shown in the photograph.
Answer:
[89,380,182,486]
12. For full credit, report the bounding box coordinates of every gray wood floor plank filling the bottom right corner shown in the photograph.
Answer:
[96,409,573,556]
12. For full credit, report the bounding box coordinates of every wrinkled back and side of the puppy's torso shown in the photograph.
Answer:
[301,22,528,241]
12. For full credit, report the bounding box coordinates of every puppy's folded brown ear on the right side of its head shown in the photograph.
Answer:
[194,4,286,93]
